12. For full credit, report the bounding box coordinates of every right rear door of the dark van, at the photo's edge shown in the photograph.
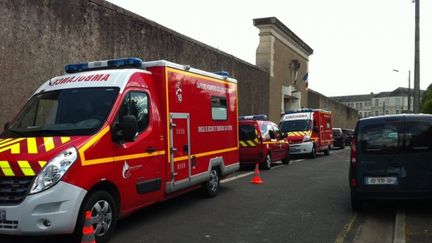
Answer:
[402,116,432,191]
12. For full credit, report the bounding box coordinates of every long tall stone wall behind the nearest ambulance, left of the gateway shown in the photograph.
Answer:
[0,0,269,126]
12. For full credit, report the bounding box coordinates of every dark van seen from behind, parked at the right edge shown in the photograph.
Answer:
[349,114,432,210]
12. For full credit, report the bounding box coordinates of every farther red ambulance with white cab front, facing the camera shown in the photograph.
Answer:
[279,109,333,158]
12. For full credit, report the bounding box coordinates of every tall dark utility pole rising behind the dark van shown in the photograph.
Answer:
[413,0,420,113]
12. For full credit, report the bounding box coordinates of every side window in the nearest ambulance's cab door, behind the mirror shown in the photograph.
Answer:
[116,91,149,132]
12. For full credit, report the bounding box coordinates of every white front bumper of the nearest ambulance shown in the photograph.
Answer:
[0,181,87,235]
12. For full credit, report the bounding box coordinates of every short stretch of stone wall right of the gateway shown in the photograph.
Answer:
[307,89,358,128]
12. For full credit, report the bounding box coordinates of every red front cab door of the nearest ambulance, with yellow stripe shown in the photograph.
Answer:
[114,90,165,208]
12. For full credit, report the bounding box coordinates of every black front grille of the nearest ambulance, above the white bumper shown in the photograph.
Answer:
[0,177,33,204]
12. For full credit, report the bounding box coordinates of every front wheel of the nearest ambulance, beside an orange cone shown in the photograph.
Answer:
[74,191,118,243]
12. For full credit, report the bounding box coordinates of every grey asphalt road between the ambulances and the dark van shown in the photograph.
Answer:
[0,148,432,243]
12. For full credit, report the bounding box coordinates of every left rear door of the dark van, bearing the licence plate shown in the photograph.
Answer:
[356,117,407,191]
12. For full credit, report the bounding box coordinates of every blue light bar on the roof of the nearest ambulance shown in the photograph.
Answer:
[65,57,143,73]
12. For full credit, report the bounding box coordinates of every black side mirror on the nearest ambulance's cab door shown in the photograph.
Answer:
[112,115,138,143]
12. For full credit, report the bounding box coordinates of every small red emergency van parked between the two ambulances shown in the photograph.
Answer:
[239,115,289,169]
